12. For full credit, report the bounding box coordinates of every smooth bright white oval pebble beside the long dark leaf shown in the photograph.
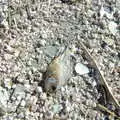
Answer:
[75,63,89,75]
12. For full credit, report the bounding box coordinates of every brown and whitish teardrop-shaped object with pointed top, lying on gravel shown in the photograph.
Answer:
[44,48,72,91]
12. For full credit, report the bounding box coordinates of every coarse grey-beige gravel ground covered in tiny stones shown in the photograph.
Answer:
[0,0,120,120]
